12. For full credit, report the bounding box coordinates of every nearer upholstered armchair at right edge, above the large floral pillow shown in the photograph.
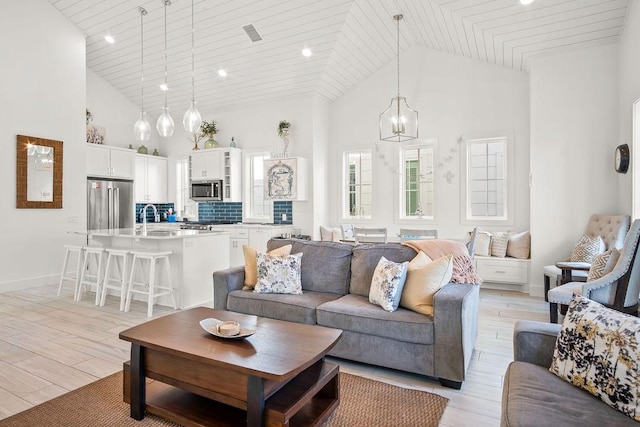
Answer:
[548,219,640,323]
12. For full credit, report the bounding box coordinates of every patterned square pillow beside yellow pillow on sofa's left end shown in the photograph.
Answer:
[253,252,302,294]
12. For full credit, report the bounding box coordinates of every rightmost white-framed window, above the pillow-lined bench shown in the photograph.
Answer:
[466,137,507,220]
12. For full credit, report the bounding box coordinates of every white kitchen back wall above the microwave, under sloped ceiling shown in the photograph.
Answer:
[160,94,326,234]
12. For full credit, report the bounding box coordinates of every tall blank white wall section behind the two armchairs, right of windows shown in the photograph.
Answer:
[530,45,626,296]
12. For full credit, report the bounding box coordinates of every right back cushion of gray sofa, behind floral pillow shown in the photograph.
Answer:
[348,243,417,298]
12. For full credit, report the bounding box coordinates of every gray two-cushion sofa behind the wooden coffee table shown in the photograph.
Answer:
[213,239,480,388]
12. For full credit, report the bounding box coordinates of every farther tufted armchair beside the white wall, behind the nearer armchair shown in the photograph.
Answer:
[543,214,631,301]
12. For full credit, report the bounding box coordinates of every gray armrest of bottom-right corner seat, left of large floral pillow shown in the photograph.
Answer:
[513,320,562,368]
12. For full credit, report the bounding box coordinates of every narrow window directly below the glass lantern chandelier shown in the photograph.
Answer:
[400,144,434,219]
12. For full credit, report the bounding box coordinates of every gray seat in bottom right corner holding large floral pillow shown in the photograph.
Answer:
[500,320,639,427]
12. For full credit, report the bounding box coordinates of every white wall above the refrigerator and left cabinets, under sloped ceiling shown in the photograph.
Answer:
[87,68,160,154]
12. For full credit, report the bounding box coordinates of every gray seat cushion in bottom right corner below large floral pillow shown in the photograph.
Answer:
[501,362,638,427]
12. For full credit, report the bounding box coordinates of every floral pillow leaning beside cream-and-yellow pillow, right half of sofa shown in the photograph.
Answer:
[369,257,409,311]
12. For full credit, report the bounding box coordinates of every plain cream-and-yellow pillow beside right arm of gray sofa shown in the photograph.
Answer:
[400,252,453,316]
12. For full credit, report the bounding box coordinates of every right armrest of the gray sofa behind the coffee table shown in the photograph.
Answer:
[433,283,480,382]
